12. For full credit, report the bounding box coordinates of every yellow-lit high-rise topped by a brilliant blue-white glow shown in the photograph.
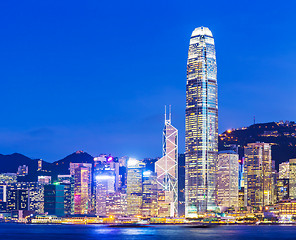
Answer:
[126,158,145,216]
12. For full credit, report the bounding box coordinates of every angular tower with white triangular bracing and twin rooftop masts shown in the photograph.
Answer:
[155,106,178,216]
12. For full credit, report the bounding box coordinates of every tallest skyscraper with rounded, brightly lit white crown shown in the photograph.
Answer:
[185,27,218,217]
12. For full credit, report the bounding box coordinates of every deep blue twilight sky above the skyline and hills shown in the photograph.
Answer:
[0,0,296,161]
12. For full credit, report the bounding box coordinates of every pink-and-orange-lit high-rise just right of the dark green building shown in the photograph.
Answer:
[70,163,92,214]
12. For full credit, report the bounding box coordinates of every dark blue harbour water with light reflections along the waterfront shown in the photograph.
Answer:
[0,224,296,240]
